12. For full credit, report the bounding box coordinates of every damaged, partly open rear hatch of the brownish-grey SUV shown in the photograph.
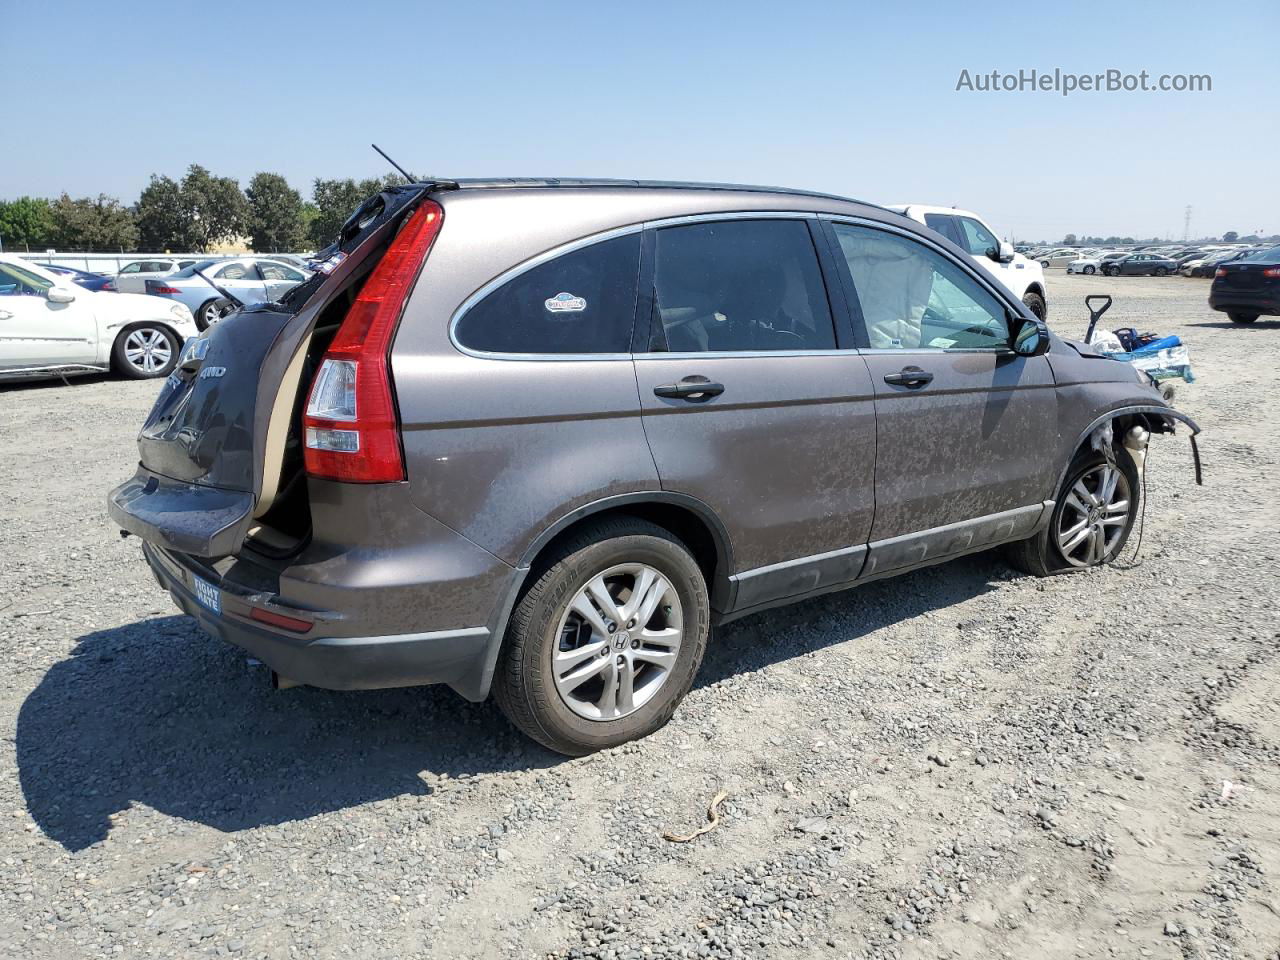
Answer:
[108,183,440,558]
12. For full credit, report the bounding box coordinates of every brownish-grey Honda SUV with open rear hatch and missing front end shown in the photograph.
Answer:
[109,180,1194,754]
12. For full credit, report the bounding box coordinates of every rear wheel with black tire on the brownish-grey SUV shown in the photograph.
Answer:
[494,517,710,756]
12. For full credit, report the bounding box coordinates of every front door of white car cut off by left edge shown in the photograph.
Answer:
[0,261,100,370]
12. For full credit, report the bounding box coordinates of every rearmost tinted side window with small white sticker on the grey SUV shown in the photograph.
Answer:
[454,233,640,353]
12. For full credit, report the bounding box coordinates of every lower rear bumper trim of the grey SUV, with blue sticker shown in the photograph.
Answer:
[142,544,492,700]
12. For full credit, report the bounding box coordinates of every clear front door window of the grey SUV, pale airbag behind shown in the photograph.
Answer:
[832,224,1009,349]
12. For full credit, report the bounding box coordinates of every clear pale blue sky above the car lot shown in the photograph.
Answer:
[0,0,1280,239]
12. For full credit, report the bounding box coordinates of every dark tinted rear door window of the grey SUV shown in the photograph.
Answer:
[653,220,836,353]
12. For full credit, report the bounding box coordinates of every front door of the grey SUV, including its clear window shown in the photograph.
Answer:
[831,221,1057,573]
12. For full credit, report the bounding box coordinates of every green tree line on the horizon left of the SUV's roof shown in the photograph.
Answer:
[0,164,403,253]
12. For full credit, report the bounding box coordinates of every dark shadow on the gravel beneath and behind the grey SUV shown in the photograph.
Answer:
[17,557,1007,851]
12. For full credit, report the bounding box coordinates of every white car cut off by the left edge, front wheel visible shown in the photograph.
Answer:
[0,253,196,380]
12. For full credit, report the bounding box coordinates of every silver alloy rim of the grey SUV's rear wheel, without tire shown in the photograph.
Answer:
[552,563,684,721]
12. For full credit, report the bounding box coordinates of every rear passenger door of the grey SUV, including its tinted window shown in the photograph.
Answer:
[635,214,876,608]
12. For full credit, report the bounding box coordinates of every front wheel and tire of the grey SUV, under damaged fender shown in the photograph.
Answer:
[1009,449,1142,577]
